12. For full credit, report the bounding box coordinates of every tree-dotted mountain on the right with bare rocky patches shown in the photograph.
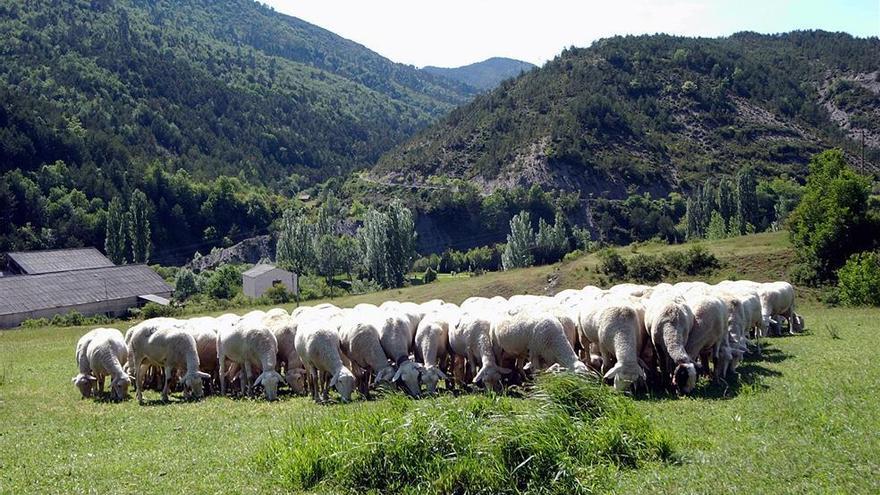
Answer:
[372,31,880,199]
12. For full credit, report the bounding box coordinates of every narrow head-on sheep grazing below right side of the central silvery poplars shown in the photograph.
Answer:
[379,305,422,397]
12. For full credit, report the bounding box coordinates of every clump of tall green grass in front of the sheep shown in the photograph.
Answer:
[257,374,672,494]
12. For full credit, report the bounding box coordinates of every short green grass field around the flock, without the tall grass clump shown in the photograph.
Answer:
[0,234,880,493]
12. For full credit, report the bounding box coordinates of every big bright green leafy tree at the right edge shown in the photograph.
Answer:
[789,150,880,283]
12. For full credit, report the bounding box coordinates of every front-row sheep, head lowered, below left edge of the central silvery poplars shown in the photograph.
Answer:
[339,312,396,397]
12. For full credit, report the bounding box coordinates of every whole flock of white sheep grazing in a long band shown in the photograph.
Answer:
[73,281,803,402]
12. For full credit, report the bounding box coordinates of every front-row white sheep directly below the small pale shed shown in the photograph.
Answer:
[217,311,284,401]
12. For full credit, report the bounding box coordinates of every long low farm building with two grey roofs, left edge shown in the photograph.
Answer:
[0,248,172,328]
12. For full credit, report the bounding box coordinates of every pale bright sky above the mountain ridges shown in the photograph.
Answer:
[261,0,880,67]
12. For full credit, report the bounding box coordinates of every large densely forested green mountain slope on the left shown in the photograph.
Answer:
[0,0,475,188]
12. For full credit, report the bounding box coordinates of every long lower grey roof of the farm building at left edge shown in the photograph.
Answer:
[0,265,172,315]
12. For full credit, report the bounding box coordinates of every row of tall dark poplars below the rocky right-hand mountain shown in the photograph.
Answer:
[685,167,758,239]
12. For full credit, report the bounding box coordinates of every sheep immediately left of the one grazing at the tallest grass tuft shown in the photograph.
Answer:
[448,308,511,391]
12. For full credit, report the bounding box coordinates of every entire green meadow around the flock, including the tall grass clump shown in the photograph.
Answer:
[0,233,880,493]
